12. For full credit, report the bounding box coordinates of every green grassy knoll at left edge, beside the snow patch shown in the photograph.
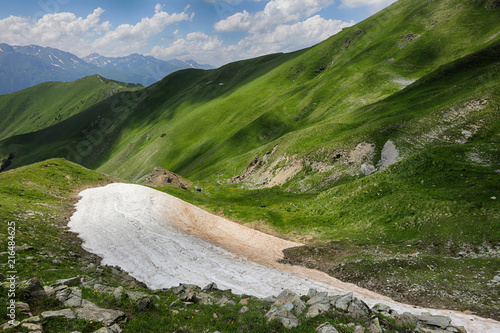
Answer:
[0,159,115,283]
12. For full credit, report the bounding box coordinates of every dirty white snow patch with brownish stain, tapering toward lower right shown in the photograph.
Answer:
[68,184,500,333]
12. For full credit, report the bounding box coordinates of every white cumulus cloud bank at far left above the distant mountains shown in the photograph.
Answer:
[0,4,190,56]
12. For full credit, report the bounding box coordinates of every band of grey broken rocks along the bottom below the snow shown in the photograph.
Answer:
[0,278,466,333]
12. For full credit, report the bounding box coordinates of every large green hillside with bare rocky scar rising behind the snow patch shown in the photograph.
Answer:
[0,0,500,319]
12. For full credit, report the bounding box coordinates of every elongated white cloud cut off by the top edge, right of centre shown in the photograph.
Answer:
[214,0,334,33]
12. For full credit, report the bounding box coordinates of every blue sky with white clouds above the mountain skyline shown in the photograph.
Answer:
[0,0,395,66]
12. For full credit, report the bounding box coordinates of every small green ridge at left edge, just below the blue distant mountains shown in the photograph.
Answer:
[0,75,142,139]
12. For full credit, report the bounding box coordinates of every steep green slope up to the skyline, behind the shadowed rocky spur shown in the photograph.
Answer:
[1,0,500,179]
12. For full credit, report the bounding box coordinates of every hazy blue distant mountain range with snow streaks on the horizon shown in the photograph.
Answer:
[0,44,214,94]
